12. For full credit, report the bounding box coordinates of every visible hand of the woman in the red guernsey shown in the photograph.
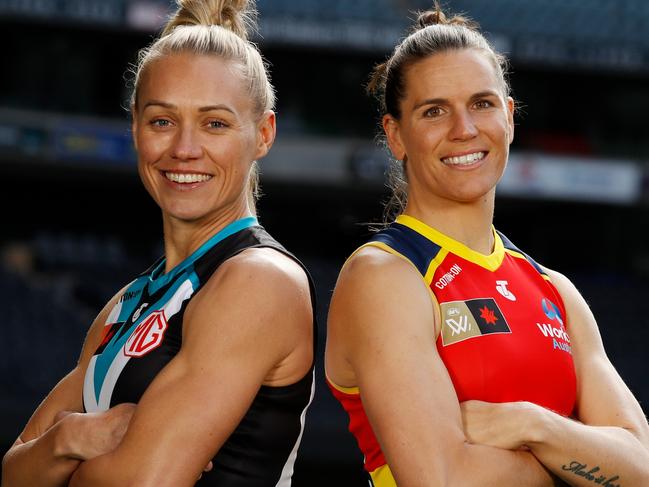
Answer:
[460,401,540,450]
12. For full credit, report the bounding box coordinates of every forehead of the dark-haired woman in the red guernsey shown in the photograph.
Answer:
[404,49,503,99]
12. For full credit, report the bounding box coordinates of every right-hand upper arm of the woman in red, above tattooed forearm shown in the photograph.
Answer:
[548,270,649,447]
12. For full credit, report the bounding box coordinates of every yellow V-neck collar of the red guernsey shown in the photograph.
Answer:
[395,214,505,271]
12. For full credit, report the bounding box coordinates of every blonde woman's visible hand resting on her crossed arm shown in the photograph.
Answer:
[62,403,136,460]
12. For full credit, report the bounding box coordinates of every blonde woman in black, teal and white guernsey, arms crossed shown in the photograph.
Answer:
[2,0,314,487]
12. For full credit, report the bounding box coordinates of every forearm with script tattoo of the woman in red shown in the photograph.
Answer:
[526,410,649,487]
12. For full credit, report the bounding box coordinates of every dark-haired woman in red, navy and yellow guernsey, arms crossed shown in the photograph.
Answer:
[326,4,649,487]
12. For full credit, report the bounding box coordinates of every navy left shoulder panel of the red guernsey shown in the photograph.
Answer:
[368,222,441,276]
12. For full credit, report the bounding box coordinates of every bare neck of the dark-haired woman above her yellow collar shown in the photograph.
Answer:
[404,190,495,255]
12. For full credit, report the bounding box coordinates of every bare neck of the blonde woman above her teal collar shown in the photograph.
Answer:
[163,200,256,272]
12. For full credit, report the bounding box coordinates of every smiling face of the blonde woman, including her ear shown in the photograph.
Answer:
[133,54,275,221]
